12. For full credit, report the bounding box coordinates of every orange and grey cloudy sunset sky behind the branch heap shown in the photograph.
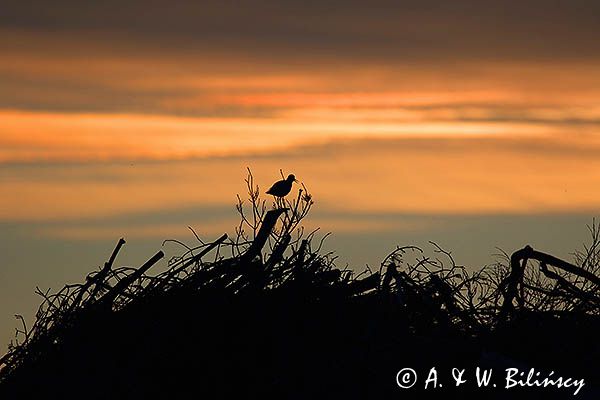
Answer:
[0,0,600,346]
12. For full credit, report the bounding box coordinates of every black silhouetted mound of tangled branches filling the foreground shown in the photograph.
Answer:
[0,210,600,400]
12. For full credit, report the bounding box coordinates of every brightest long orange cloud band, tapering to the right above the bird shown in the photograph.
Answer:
[0,111,555,162]
